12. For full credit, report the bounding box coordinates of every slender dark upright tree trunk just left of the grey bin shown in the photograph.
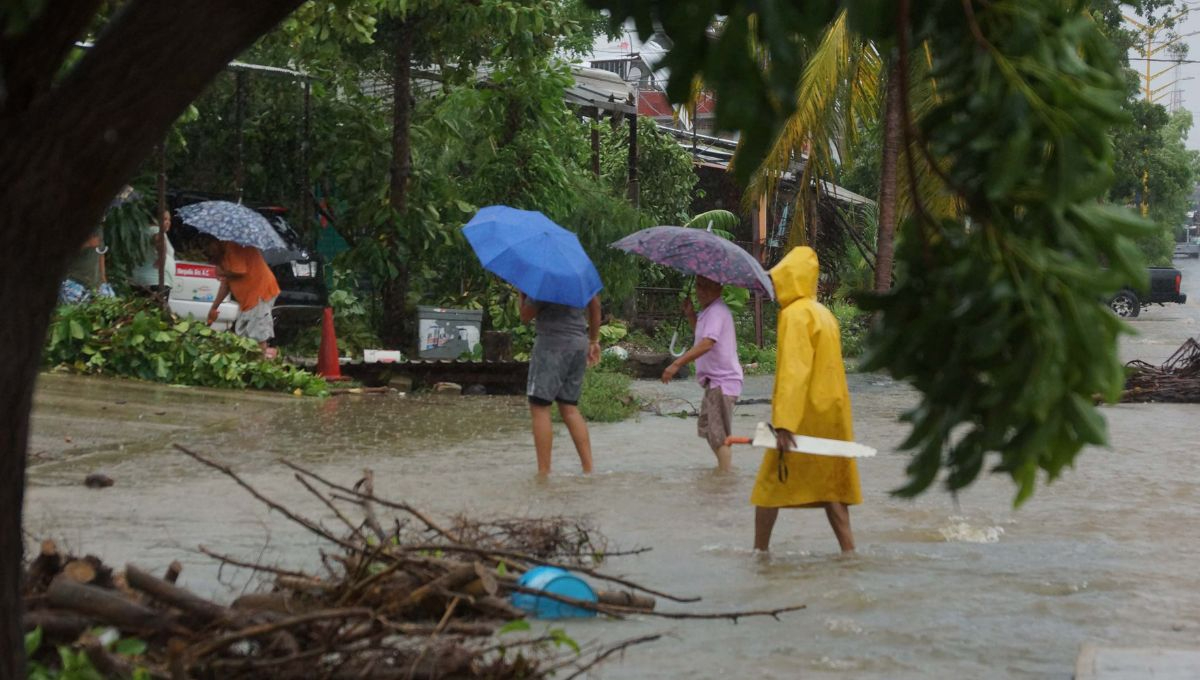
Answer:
[380,18,413,349]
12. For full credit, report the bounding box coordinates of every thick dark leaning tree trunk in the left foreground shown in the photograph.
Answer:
[0,0,301,680]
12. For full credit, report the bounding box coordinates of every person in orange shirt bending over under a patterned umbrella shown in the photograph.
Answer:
[204,236,280,359]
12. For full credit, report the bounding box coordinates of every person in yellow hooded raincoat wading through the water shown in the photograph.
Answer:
[750,246,863,553]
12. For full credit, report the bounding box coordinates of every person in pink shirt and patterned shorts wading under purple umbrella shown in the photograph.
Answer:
[662,276,743,473]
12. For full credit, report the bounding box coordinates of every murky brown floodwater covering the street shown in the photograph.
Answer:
[26,260,1200,680]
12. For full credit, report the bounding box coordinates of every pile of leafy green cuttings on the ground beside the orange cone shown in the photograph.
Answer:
[44,299,326,396]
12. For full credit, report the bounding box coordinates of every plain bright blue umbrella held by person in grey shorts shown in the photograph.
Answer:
[462,205,604,307]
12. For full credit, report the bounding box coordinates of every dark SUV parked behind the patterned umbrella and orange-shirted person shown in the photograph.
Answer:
[168,192,329,342]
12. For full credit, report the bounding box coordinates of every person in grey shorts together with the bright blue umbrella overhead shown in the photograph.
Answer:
[463,205,602,476]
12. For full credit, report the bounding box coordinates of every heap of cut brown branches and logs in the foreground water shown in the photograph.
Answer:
[24,447,803,680]
